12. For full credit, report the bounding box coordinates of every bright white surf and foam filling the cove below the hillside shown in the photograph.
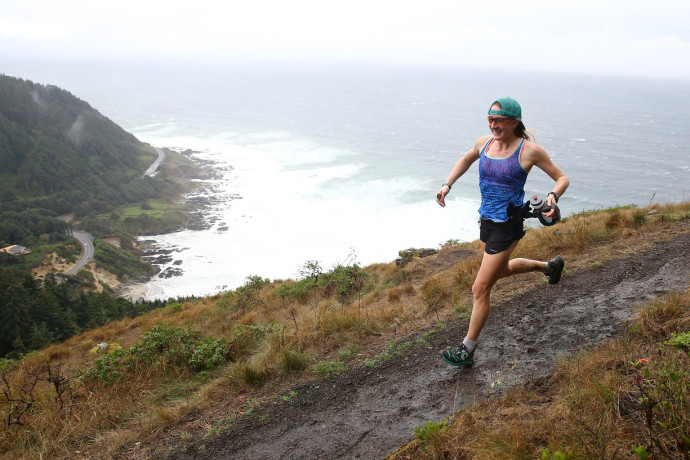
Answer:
[135,134,478,299]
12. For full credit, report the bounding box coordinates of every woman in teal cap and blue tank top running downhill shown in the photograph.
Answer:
[436,97,570,366]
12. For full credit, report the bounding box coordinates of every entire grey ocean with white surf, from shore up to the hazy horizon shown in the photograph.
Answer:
[0,60,690,299]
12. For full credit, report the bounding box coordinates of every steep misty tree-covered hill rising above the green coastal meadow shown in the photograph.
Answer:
[0,75,160,215]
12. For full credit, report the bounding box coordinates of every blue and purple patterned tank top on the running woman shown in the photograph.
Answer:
[479,138,527,222]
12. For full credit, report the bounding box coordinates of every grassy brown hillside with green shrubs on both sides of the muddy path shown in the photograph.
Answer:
[0,203,690,458]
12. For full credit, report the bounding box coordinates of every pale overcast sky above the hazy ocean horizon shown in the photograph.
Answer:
[0,0,690,79]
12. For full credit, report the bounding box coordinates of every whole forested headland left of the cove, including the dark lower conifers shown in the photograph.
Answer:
[0,75,194,358]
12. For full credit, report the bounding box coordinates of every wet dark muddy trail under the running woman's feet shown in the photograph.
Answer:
[170,233,690,459]
